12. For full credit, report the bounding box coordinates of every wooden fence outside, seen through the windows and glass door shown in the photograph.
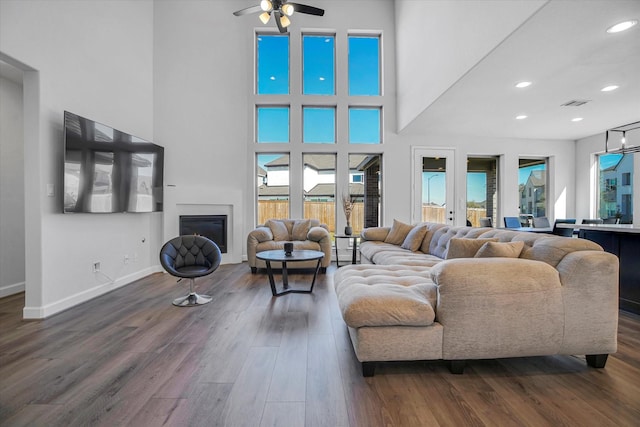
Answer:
[258,200,487,234]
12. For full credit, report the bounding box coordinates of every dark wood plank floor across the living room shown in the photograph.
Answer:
[0,264,640,427]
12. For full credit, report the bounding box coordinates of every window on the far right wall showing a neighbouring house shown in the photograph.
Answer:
[597,154,633,224]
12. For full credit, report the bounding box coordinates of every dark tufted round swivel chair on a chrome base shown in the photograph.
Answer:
[160,235,222,307]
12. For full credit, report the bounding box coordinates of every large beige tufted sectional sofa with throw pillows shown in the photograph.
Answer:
[334,221,618,376]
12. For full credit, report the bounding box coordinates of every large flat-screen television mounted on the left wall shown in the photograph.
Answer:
[64,111,164,213]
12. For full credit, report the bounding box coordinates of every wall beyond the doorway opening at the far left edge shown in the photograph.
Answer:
[0,76,25,297]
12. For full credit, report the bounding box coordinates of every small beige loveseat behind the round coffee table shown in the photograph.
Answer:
[247,219,331,274]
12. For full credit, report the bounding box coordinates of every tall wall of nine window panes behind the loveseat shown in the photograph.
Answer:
[250,31,384,233]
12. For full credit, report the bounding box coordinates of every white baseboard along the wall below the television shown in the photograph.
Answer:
[22,265,164,319]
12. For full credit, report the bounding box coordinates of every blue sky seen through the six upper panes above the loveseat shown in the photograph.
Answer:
[256,35,381,144]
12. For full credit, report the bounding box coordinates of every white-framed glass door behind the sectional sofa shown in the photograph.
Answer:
[411,148,455,225]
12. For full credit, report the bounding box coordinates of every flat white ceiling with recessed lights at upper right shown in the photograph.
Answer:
[402,0,640,140]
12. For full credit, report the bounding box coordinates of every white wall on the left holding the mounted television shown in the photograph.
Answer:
[0,0,162,318]
